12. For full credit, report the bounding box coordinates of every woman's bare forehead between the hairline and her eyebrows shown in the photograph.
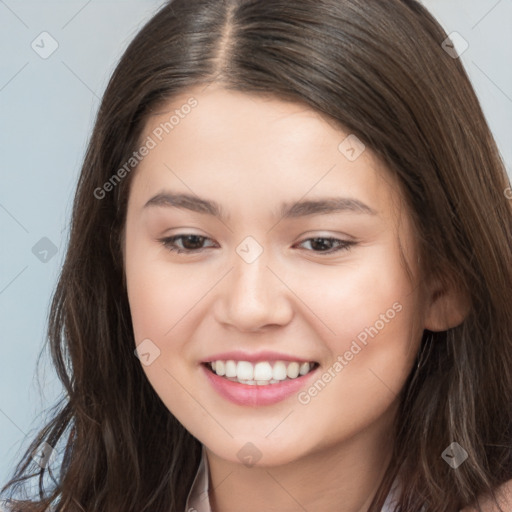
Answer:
[133,86,398,220]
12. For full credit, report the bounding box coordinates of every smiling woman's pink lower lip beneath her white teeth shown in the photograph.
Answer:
[201,364,318,406]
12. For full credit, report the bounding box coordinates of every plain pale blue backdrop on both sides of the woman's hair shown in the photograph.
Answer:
[0,0,512,487]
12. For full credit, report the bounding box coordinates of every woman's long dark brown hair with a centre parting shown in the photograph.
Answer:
[2,0,512,512]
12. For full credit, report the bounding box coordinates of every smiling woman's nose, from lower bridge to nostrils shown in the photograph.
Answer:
[215,247,293,332]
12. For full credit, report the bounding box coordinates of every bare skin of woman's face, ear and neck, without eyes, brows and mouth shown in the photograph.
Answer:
[123,86,463,512]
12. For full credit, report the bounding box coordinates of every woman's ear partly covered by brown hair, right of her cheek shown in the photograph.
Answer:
[424,279,470,332]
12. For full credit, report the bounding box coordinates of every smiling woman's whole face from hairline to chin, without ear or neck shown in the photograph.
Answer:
[123,86,425,465]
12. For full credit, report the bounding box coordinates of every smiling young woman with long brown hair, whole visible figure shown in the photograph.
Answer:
[4,0,512,512]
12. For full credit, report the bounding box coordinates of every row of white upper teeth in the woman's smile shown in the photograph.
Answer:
[210,360,314,384]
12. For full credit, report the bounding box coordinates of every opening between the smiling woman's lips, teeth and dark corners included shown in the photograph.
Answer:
[202,359,319,386]
